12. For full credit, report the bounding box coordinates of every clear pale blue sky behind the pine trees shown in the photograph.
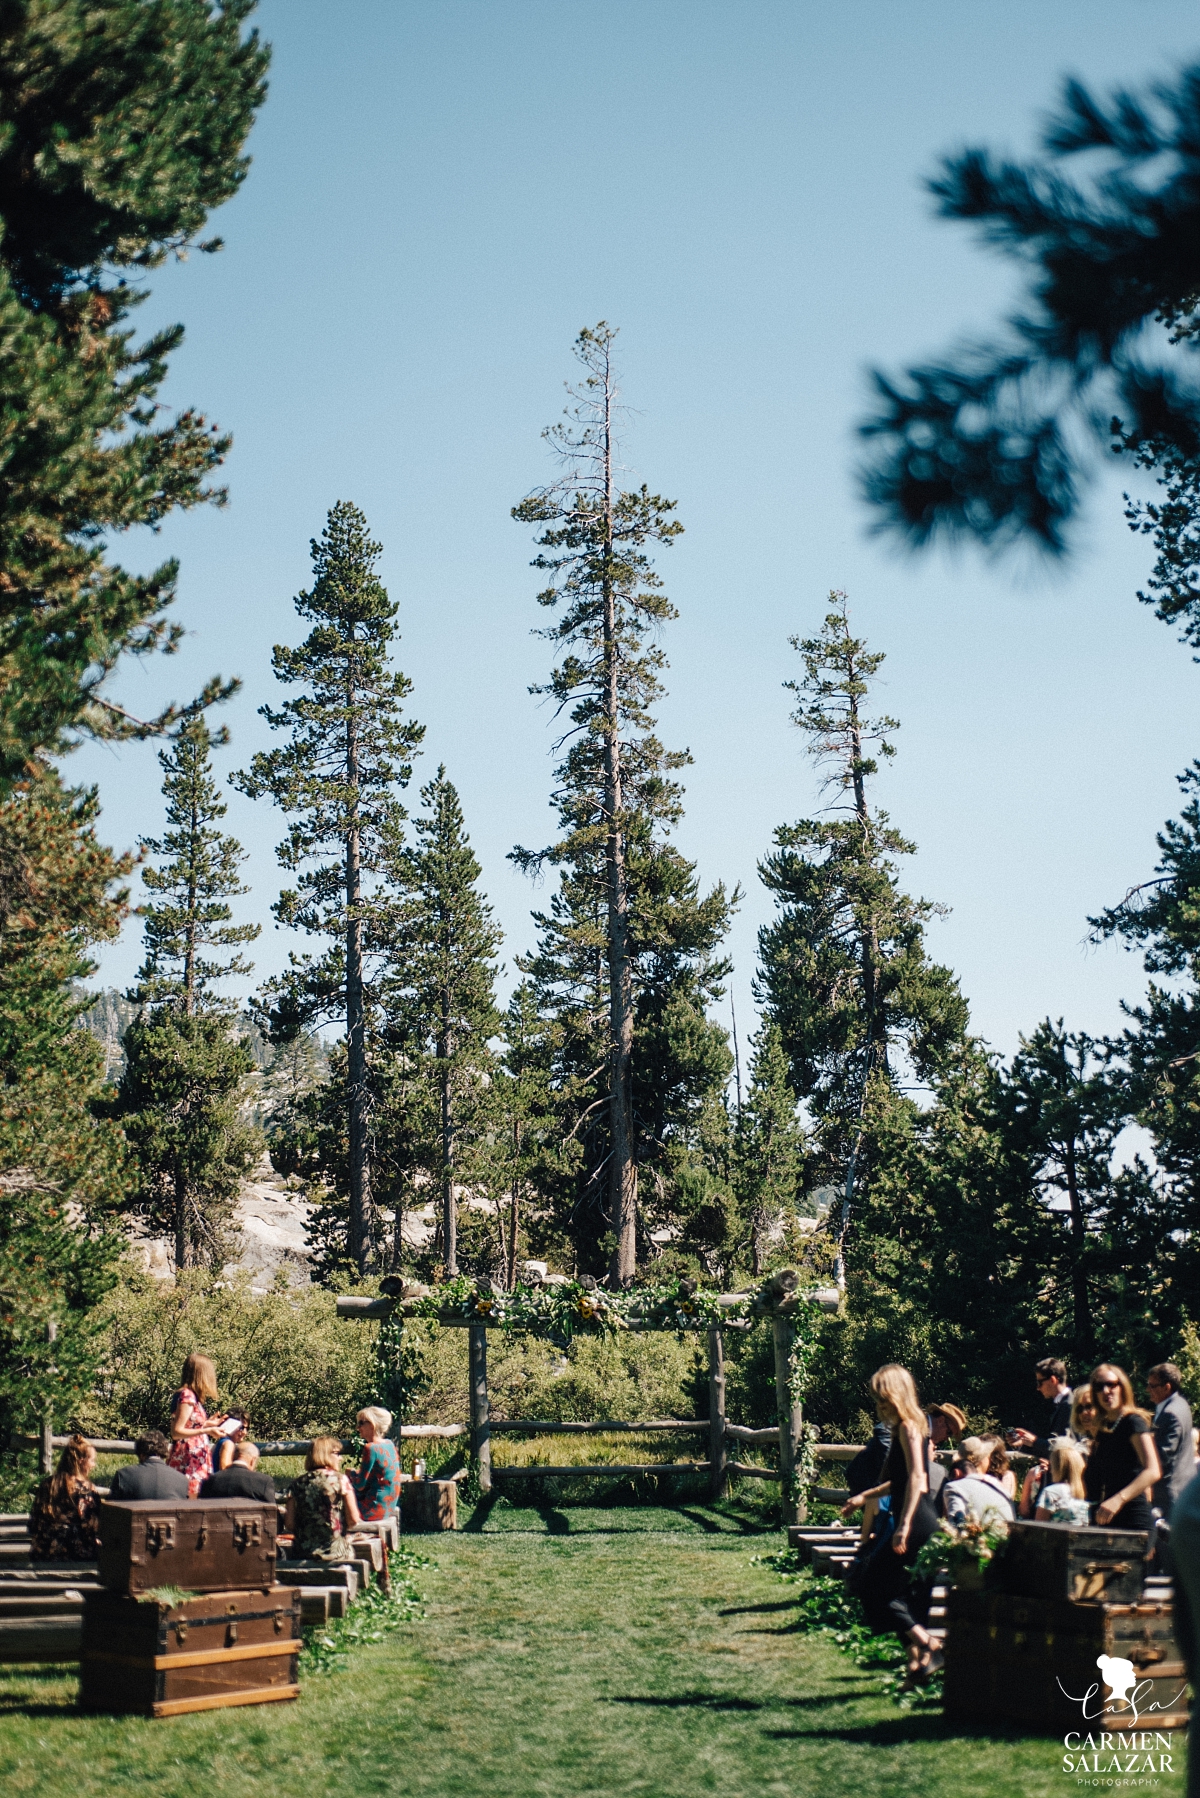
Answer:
[68,0,1200,1052]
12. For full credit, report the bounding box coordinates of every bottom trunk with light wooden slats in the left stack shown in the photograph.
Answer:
[79,1586,300,1717]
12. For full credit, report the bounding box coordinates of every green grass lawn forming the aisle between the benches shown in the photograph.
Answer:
[0,1503,1184,1798]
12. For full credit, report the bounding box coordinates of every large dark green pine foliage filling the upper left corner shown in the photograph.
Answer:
[0,0,266,782]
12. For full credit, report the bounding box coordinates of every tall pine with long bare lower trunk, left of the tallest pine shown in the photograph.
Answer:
[234,503,425,1271]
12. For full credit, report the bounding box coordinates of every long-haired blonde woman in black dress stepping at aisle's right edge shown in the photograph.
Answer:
[842,1363,941,1690]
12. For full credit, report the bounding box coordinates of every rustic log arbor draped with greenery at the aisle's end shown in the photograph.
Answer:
[336,1271,838,1514]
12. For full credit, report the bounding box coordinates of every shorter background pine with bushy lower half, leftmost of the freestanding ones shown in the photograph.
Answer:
[112,719,259,1268]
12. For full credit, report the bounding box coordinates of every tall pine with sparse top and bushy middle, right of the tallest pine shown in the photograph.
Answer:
[756,593,968,1275]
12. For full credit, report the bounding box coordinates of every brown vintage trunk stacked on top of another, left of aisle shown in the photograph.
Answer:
[99,1498,279,1597]
